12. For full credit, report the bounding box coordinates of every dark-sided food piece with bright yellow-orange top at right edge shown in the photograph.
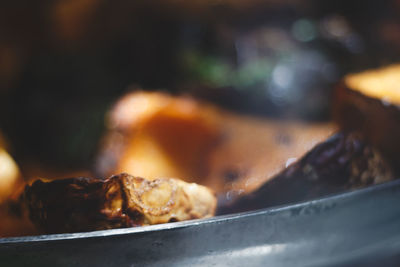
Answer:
[334,65,400,170]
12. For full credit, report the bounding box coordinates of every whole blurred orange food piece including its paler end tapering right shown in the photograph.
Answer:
[97,92,336,197]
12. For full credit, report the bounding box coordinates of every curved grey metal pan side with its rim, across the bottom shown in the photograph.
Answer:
[0,180,400,266]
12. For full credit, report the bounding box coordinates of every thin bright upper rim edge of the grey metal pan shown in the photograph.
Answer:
[0,179,400,244]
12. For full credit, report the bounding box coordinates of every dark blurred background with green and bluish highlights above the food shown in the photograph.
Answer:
[0,0,400,175]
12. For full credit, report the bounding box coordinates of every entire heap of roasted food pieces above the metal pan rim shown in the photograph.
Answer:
[0,65,400,236]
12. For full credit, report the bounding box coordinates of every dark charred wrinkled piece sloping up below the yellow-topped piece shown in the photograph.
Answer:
[218,133,395,214]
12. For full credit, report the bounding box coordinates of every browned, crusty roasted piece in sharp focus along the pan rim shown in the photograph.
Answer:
[24,173,216,233]
